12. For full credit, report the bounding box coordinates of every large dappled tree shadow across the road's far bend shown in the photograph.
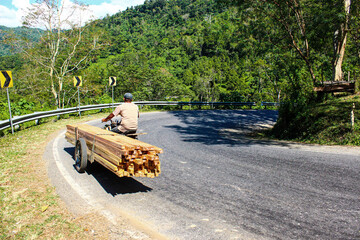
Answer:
[166,110,294,146]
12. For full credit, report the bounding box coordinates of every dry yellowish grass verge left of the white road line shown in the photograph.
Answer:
[0,113,106,239]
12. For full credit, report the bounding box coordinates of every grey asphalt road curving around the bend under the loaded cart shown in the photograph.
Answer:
[45,110,360,239]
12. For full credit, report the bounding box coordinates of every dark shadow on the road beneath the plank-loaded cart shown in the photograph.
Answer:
[64,147,152,196]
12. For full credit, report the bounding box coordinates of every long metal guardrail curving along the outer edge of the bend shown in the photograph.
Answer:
[0,101,278,131]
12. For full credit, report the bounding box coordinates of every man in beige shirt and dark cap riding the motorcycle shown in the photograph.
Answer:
[101,93,140,135]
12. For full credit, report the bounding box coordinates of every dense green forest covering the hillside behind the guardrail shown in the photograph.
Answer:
[0,0,360,119]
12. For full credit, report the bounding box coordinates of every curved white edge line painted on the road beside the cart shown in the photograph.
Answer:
[53,131,116,225]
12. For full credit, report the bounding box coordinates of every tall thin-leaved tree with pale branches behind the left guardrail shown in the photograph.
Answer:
[23,0,107,107]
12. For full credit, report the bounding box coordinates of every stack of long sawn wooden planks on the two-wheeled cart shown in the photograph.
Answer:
[65,124,163,178]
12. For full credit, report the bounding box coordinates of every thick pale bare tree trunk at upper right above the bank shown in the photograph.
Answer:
[332,0,351,81]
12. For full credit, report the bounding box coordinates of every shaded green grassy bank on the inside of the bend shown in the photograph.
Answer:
[266,95,360,146]
